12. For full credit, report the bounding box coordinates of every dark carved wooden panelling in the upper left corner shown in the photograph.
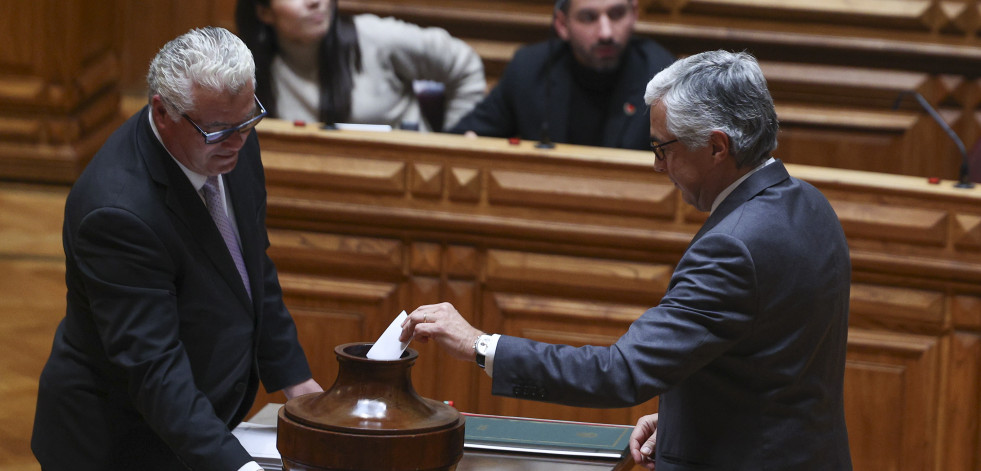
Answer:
[0,0,120,182]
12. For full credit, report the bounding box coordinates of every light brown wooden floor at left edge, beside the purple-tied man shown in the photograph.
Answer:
[0,182,68,471]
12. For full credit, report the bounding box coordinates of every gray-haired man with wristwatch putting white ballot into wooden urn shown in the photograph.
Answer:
[402,51,851,471]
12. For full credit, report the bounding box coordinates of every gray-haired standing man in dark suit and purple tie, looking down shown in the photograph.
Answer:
[31,28,322,471]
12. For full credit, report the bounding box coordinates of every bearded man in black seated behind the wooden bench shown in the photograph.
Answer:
[450,0,673,150]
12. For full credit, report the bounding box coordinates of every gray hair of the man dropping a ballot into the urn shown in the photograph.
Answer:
[644,51,779,167]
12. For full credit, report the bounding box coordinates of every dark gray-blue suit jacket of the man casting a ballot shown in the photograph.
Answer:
[493,161,851,471]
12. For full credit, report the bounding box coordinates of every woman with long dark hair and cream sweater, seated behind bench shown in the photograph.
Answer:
[235,0,485,131]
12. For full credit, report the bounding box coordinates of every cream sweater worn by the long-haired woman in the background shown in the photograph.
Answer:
[272,14,486,130]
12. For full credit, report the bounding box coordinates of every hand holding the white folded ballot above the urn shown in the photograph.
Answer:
[399,303,483,361]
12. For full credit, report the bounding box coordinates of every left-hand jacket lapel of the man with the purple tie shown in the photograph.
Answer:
[138,108,253,313]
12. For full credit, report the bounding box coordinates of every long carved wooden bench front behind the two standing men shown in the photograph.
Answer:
[251,120,981,470]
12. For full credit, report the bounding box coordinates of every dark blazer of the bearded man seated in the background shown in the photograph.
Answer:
[450,38,674,150]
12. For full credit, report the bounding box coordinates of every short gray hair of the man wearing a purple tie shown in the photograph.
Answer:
[146,26,255,120]
